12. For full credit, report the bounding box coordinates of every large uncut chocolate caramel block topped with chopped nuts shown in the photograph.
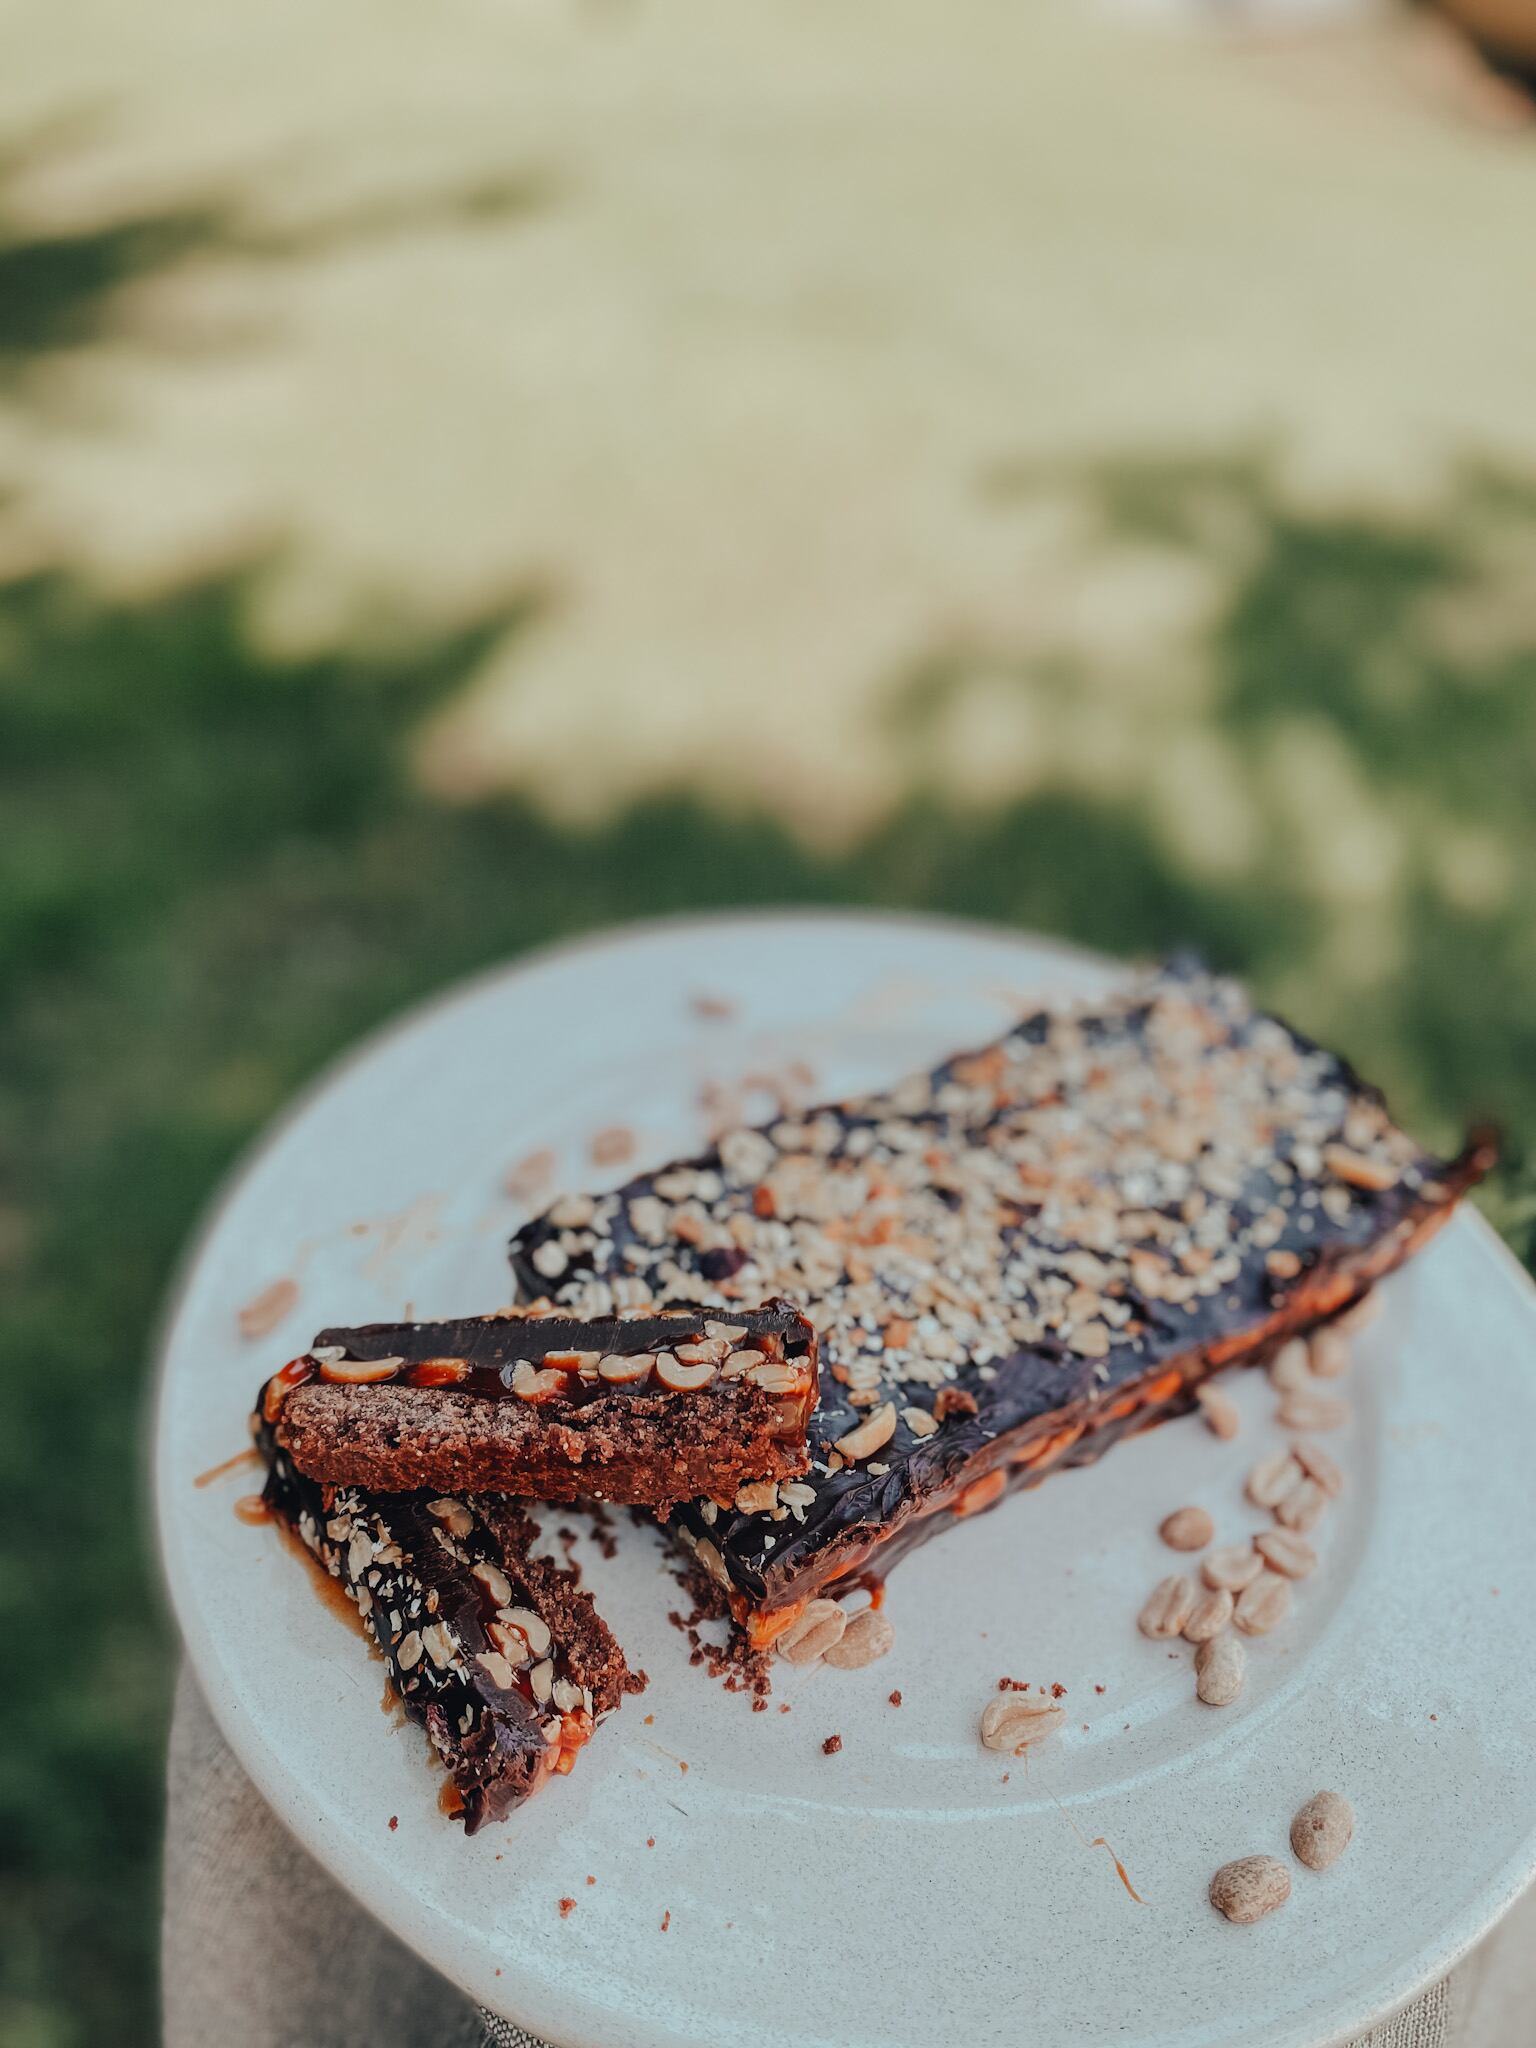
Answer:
[512,963,1493,1642]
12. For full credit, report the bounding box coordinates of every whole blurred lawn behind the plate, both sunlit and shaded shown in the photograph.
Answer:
[0,0,1536,2048]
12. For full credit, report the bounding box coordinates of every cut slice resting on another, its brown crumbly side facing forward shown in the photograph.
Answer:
[268,1300,817,1507]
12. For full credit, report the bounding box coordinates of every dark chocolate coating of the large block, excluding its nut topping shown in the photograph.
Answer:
[510,961,1493,1608]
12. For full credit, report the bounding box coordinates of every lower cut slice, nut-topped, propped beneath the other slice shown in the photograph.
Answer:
[256,1409,645,1835]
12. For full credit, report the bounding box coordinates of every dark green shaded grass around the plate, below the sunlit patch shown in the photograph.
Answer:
[0,461,1536,2048]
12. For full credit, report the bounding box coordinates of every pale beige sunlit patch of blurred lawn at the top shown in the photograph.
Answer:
[0,0,1536,839]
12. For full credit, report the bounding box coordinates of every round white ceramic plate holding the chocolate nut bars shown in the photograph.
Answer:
[156,915,1536,2048]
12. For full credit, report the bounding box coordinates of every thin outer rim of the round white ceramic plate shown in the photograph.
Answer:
[145,903,1536,2048]
